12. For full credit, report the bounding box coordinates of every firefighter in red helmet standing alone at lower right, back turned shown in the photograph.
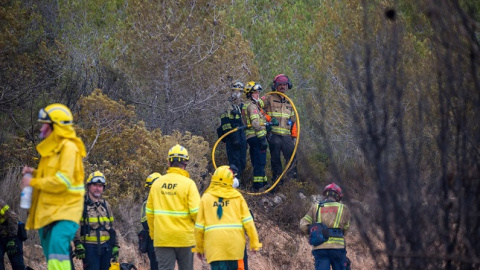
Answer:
[300,183,350,270]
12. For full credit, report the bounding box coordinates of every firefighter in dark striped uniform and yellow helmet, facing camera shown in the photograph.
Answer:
[74,171,120,270]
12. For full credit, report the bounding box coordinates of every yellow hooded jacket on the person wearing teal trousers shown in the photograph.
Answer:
[26,131,86,229]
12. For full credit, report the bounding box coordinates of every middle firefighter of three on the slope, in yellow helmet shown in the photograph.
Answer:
[242,81,268,191]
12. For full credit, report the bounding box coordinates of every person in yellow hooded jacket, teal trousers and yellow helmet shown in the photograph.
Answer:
[21,103,86,269]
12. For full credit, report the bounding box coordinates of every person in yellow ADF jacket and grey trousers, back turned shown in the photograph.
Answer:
[145,144,200,270]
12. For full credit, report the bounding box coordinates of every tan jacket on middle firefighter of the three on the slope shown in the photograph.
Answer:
[242,100,267,139]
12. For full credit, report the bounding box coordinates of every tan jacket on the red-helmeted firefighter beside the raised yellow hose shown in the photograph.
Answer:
[261,94,296,136]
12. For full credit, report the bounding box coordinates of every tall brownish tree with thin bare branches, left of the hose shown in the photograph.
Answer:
[122,0,257,133]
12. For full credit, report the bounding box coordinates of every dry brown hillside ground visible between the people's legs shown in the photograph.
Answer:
[13,205,375,270]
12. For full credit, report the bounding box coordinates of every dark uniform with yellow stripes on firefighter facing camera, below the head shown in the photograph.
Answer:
[74,194,118,270]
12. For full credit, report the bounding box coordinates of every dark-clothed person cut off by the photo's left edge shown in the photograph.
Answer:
[0,199,25,270]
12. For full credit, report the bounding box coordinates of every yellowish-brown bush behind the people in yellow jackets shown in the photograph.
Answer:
[77,89,209,205]
